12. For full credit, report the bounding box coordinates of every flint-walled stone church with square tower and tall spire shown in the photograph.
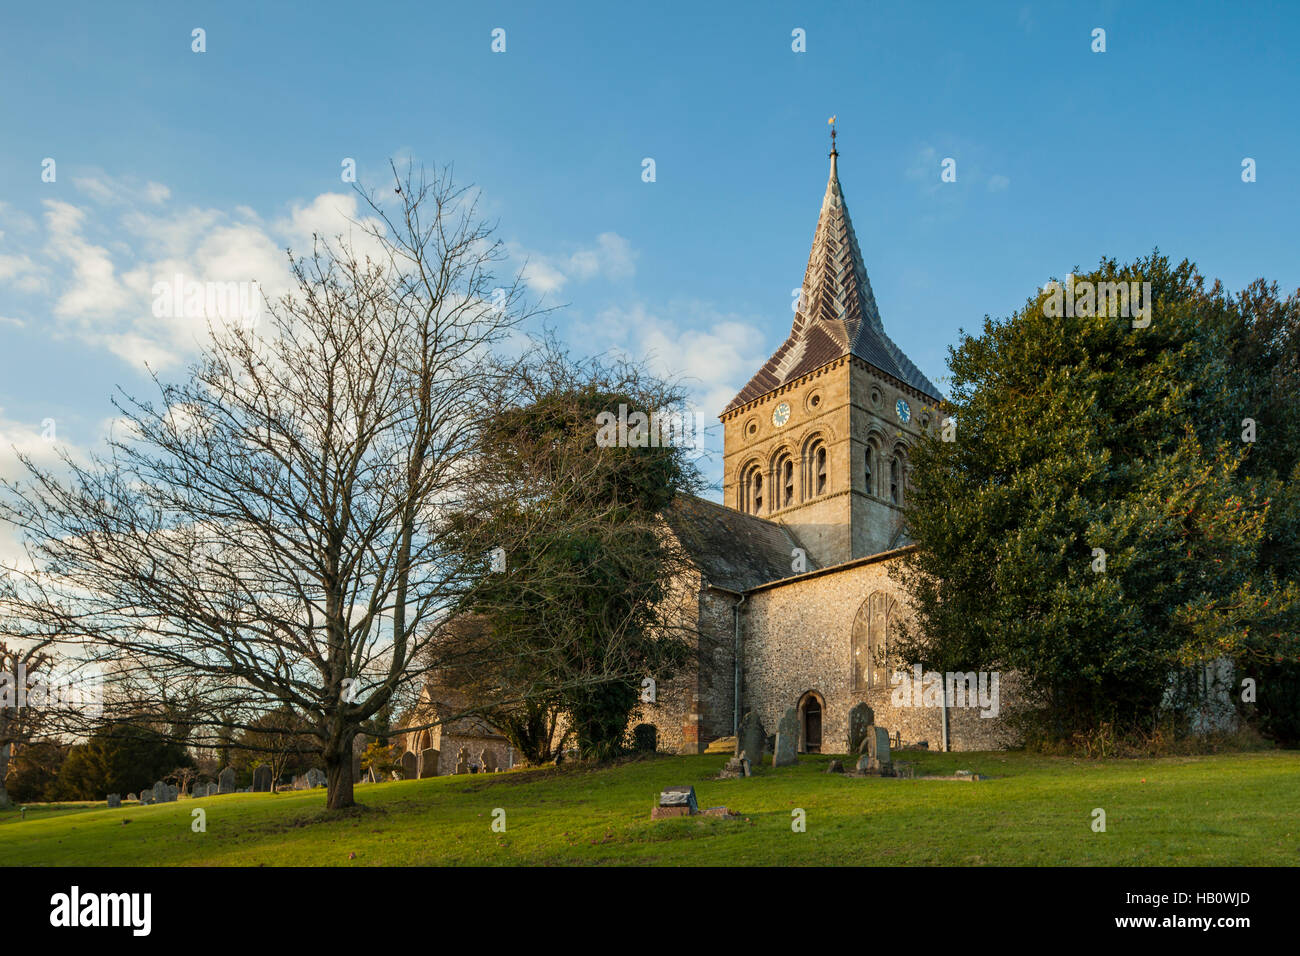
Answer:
[640,144,1014,753]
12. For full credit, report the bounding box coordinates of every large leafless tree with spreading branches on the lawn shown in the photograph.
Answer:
[0,168,536,808]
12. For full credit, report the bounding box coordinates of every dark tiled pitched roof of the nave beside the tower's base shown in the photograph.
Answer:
[663,494,800,591]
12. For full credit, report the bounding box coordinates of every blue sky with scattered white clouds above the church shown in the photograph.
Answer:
[0,3,1300,520]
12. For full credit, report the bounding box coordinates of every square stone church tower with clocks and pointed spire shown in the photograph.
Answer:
[720,138,940,570]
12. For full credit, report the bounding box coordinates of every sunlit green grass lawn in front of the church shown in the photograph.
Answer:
[0,752,1300,866]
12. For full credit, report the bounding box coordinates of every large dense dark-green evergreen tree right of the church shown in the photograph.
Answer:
[897,252,1297,736]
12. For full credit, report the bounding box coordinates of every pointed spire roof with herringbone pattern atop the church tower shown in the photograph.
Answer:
[723,148,940,415]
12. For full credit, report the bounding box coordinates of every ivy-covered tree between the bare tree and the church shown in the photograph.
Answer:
[452,345,698,762]
